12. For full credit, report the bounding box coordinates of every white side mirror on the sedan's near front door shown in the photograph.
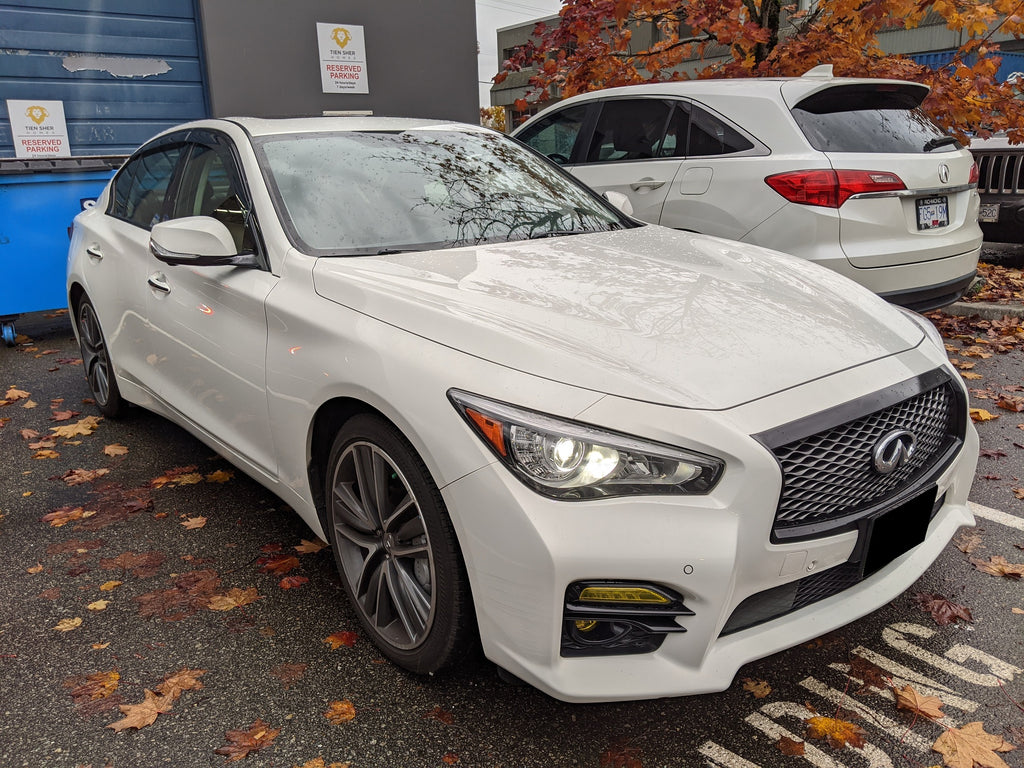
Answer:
[150,216,259,266]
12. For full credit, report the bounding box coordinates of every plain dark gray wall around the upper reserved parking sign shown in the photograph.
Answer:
[199,0,479,123]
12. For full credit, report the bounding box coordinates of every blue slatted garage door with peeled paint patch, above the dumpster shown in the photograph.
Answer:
[0,0,209,158]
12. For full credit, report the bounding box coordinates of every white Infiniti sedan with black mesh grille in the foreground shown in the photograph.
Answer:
[68,118,978,701]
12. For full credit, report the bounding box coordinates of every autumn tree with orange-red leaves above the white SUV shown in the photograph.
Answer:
[495,0,1024,141]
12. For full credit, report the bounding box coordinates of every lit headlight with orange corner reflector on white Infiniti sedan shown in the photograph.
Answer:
[449,389,725,500]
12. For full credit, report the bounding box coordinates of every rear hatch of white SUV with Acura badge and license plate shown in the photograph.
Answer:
[782,78,981,268]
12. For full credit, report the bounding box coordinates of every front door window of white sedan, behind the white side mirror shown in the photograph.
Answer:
[171,144,256,253]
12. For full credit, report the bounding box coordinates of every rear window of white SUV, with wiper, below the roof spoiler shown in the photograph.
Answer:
[793,84,961,153]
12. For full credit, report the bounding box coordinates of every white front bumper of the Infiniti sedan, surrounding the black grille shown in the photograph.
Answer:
[442,351,978,702]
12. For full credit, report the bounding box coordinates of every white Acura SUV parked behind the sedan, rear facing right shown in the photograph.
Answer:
[512,66,982,311]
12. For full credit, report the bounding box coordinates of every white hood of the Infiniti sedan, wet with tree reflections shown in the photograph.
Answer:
[313,226,923,410]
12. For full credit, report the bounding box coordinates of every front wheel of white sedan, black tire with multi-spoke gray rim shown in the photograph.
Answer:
[325,414,472,674]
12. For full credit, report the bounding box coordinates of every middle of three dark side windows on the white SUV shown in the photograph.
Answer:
[587,98,672,163]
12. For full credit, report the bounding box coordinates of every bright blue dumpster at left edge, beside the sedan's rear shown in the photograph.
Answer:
[0,157,124,346]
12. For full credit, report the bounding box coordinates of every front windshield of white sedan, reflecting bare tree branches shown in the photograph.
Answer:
[257,127,630,255]
